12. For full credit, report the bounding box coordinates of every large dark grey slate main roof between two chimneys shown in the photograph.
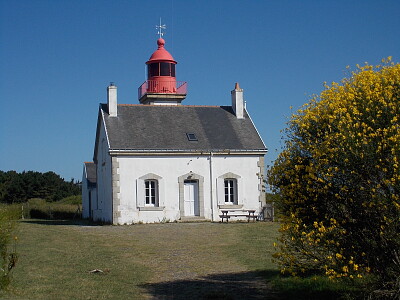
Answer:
[100,104,266,151]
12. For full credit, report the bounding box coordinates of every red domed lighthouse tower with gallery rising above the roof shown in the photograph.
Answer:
[138,37,187,105]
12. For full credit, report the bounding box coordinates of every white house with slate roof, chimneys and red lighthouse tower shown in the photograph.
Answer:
[82,38,267,224]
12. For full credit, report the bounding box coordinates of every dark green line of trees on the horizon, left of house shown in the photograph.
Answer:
[0,170,81,203]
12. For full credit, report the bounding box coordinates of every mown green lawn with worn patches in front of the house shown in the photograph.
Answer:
[0,220,368,300]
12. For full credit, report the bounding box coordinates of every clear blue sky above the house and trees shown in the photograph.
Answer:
[0,0,400,180]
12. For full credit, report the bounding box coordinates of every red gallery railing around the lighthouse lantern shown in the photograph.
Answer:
[138,80,187,99]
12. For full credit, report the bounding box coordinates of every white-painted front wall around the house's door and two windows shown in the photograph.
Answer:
[113,151,261,224]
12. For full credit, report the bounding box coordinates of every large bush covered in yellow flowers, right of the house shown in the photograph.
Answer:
[268,58,400,290]
